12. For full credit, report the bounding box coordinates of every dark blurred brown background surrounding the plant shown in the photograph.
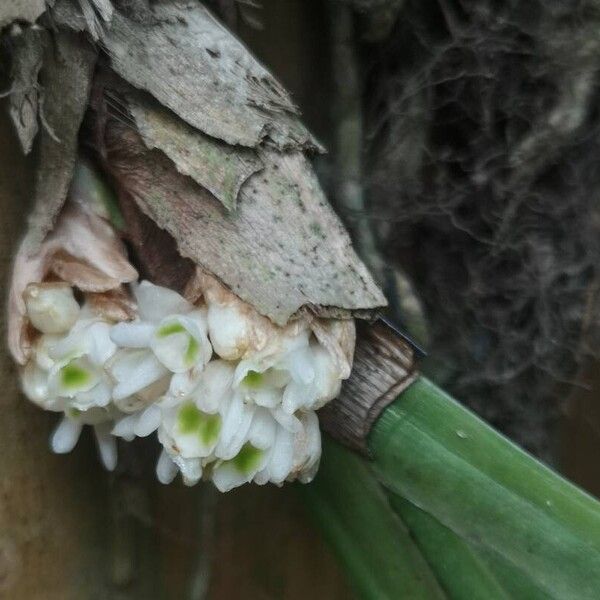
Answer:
[0,0,600,600]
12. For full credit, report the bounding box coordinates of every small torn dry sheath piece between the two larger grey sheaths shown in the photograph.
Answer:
[127,89,263,210]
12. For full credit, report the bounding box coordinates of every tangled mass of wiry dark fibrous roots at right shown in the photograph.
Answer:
[354,0,600,458]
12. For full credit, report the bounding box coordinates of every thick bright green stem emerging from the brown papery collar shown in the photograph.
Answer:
[369,378,600,599]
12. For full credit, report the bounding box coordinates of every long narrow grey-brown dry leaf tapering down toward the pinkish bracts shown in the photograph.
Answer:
[27,31,96,252]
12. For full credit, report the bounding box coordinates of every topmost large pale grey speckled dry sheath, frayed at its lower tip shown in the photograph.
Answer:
[102,1,318,148]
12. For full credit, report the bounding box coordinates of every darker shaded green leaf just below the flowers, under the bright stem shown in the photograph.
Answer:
[298,439,446,600]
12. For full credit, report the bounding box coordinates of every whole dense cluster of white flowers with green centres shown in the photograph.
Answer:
[22,280,353,491]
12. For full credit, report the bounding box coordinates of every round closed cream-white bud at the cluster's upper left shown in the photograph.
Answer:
[24,283,79,333]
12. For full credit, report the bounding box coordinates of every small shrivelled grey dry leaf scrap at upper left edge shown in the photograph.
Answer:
[9,27,45,154]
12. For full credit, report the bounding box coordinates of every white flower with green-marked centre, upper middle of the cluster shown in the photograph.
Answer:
[111,281,212,376]
